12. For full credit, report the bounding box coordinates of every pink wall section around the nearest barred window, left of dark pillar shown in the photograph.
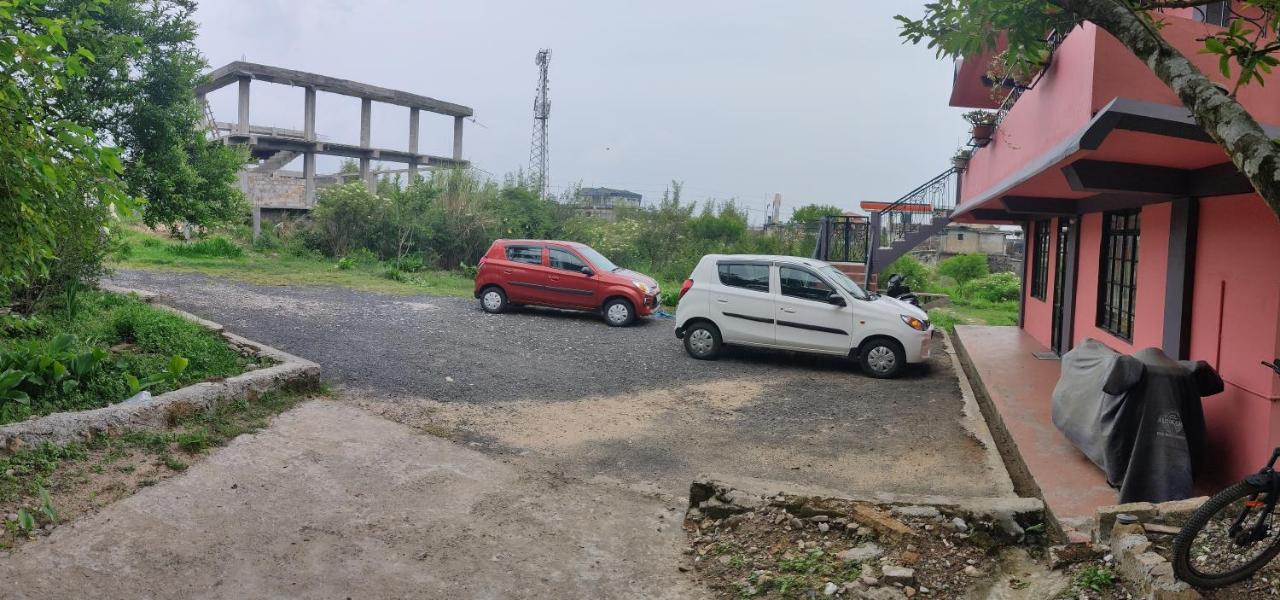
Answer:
[1075,203,1171,353]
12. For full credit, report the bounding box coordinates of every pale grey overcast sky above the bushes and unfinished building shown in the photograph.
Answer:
[196,0,968,221]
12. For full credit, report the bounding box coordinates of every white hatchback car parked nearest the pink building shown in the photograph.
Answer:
[676,255,933,377]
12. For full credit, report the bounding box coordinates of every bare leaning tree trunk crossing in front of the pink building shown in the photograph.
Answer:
[1051,0,1280,219]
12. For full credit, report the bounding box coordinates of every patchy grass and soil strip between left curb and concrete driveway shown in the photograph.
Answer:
[0,388,320,549]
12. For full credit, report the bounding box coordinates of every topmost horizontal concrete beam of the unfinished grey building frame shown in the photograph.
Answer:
[196,60,474,116]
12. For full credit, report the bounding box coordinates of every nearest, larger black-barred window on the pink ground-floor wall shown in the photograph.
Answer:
[1098,209,1140,342]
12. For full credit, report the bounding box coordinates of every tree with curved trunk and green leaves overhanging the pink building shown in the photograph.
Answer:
[896,0,1280,217]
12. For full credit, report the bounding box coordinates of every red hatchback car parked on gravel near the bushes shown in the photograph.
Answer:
[475,239,658,328]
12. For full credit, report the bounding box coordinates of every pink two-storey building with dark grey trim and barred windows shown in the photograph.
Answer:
[931,3,1280,514]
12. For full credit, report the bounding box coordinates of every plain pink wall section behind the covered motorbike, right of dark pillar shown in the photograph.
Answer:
[1190,194,1280,481]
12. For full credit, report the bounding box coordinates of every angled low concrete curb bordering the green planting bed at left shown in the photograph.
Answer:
[0,284,320,453]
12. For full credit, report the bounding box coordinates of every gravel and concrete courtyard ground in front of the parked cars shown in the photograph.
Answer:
[0,272,1011,597]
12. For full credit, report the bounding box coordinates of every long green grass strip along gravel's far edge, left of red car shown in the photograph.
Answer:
[111,228,476,297]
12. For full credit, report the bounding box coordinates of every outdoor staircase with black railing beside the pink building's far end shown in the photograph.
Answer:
[863,166,963,285]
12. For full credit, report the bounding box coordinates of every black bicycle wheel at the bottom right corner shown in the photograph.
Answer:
[1174,481,1280,587]
